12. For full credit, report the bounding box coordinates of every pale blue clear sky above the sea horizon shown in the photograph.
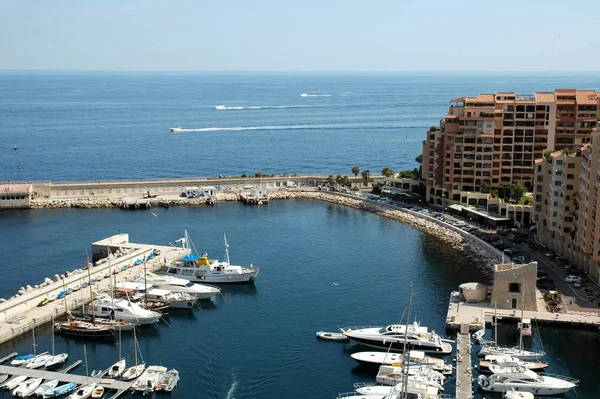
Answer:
[0,0,600,71]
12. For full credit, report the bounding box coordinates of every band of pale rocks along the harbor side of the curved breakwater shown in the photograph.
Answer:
[31,190,500,275]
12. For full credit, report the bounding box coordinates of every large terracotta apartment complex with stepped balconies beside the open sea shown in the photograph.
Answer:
[422,89,599,206]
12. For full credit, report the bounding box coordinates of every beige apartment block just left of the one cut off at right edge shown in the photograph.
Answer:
[533,150,581,254]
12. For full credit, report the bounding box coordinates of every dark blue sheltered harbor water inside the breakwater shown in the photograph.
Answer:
[0,200,600,399]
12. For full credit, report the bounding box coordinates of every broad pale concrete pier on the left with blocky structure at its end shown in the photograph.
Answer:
[0,233,185,344]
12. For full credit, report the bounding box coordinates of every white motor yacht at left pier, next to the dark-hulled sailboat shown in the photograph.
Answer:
[87,294,161,325]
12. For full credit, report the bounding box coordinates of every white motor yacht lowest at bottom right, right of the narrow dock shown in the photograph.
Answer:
[477,370,579,395]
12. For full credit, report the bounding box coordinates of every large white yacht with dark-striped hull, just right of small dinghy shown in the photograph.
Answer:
[340,321,452,355]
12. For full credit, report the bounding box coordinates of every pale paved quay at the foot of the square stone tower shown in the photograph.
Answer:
[446,290,600,332]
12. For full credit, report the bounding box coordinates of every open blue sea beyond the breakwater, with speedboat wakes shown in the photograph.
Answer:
[0,72,600,181]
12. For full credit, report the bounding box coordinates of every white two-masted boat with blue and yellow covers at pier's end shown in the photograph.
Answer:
[165,231,259,284]
